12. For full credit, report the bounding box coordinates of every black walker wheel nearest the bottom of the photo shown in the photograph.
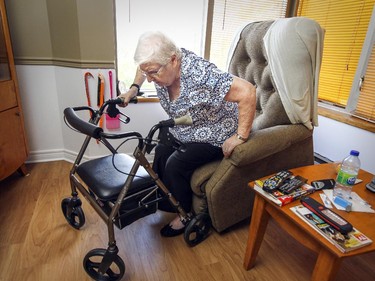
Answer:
[83,249,125,281]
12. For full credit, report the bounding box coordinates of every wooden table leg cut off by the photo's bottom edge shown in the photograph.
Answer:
[311,248,341,281]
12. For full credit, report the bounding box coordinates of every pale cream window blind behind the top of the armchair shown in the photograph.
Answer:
[209,0,288,69]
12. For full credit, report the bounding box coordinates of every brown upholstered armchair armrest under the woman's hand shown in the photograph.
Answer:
[228,124,312,167]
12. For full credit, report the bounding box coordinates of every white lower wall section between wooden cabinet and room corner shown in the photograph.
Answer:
[16,66,64,161]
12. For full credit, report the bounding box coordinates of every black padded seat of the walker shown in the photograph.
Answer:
[77,153,155,201]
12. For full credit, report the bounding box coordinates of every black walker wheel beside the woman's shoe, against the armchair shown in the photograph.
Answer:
[184,213,211,247]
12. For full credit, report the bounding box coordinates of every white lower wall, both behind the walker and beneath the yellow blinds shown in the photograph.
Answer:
[17,65,375,174]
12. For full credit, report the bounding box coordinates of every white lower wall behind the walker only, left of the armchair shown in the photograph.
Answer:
[17,65,167,162]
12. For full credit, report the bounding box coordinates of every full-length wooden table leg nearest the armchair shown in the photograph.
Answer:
[244,195,270,270]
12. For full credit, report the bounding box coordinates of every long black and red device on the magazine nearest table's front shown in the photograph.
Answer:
[301,197,353,234]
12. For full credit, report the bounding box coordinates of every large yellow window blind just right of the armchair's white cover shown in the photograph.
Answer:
[297,0,375,111]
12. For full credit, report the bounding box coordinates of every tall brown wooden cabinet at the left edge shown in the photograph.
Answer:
[0,0,28,180]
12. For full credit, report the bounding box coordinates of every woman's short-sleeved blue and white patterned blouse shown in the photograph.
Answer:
[155,48,238,147]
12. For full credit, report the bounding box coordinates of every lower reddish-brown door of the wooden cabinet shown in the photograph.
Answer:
[0,107,27,180]
